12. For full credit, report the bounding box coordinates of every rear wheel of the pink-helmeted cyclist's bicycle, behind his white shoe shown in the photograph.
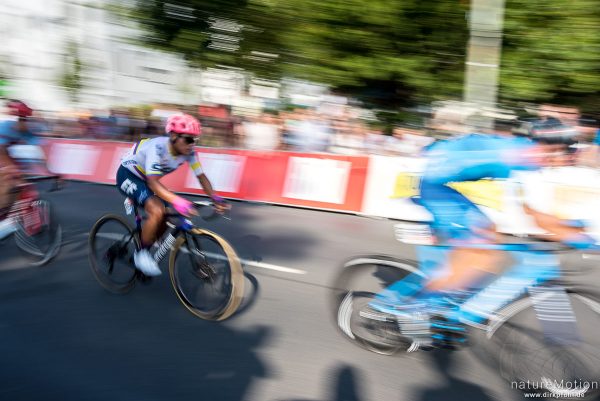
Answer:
[88,214,140,294]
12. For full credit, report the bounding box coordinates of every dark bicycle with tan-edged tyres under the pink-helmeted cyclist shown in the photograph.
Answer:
[89,198,244,320]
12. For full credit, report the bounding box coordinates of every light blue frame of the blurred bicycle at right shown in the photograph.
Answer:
[377,239,580,344]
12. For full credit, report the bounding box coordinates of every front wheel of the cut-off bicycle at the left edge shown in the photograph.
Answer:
[15,199,62,266]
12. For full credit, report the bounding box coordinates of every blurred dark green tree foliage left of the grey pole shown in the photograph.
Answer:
[130,0,468,107]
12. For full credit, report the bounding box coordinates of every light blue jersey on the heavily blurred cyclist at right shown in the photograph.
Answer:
[423,134,540,185]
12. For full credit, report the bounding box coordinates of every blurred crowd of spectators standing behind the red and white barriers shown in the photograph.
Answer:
[7,101,596,156]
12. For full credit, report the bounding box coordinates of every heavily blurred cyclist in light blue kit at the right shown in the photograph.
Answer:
[371,126,595,322]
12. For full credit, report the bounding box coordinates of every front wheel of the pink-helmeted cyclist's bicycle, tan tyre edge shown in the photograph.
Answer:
[169,228,244,320]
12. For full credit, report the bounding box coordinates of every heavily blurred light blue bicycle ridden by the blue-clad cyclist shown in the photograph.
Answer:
[333,223,600,399]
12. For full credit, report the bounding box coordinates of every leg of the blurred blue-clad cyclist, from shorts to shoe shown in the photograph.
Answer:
[372,183,504,311]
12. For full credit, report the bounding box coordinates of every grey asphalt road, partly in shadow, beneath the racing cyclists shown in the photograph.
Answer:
[0,182,596,401]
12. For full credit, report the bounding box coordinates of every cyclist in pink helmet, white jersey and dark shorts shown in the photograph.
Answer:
[117,114,229,276]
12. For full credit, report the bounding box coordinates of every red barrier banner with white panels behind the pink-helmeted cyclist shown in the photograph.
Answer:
[47,139,369,212]
